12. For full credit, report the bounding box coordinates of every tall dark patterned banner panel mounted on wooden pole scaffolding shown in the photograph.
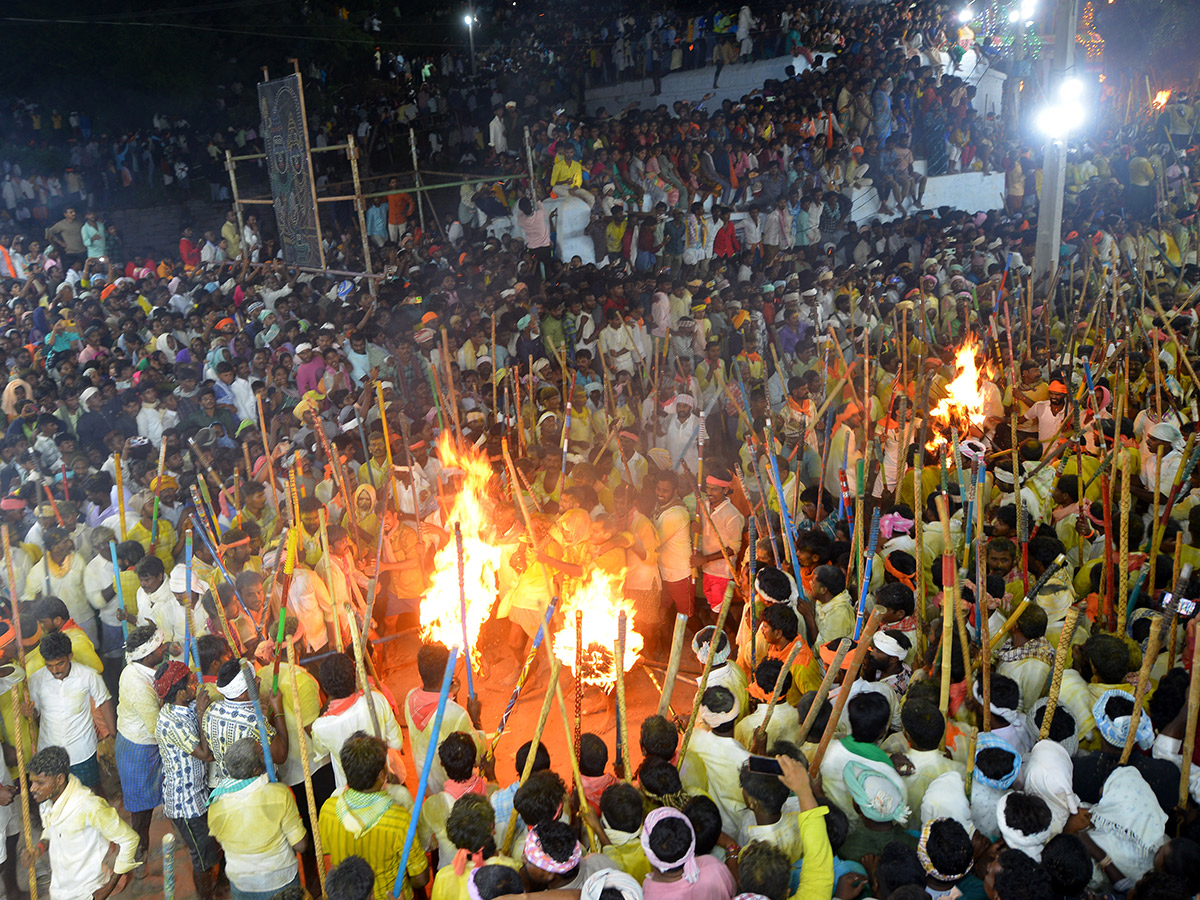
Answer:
[258,74,325,268]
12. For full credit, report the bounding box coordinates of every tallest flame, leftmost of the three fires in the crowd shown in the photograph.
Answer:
[421,432,504,664]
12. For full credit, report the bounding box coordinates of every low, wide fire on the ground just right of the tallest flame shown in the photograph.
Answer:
[554,569,642,690]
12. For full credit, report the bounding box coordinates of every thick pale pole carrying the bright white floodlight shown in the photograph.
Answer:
[1033,0,1079,283]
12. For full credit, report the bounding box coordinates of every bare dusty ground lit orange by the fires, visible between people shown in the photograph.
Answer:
[68,619,698,898]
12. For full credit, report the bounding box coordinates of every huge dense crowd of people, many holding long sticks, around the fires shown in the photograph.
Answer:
[0,4,1200,900]
